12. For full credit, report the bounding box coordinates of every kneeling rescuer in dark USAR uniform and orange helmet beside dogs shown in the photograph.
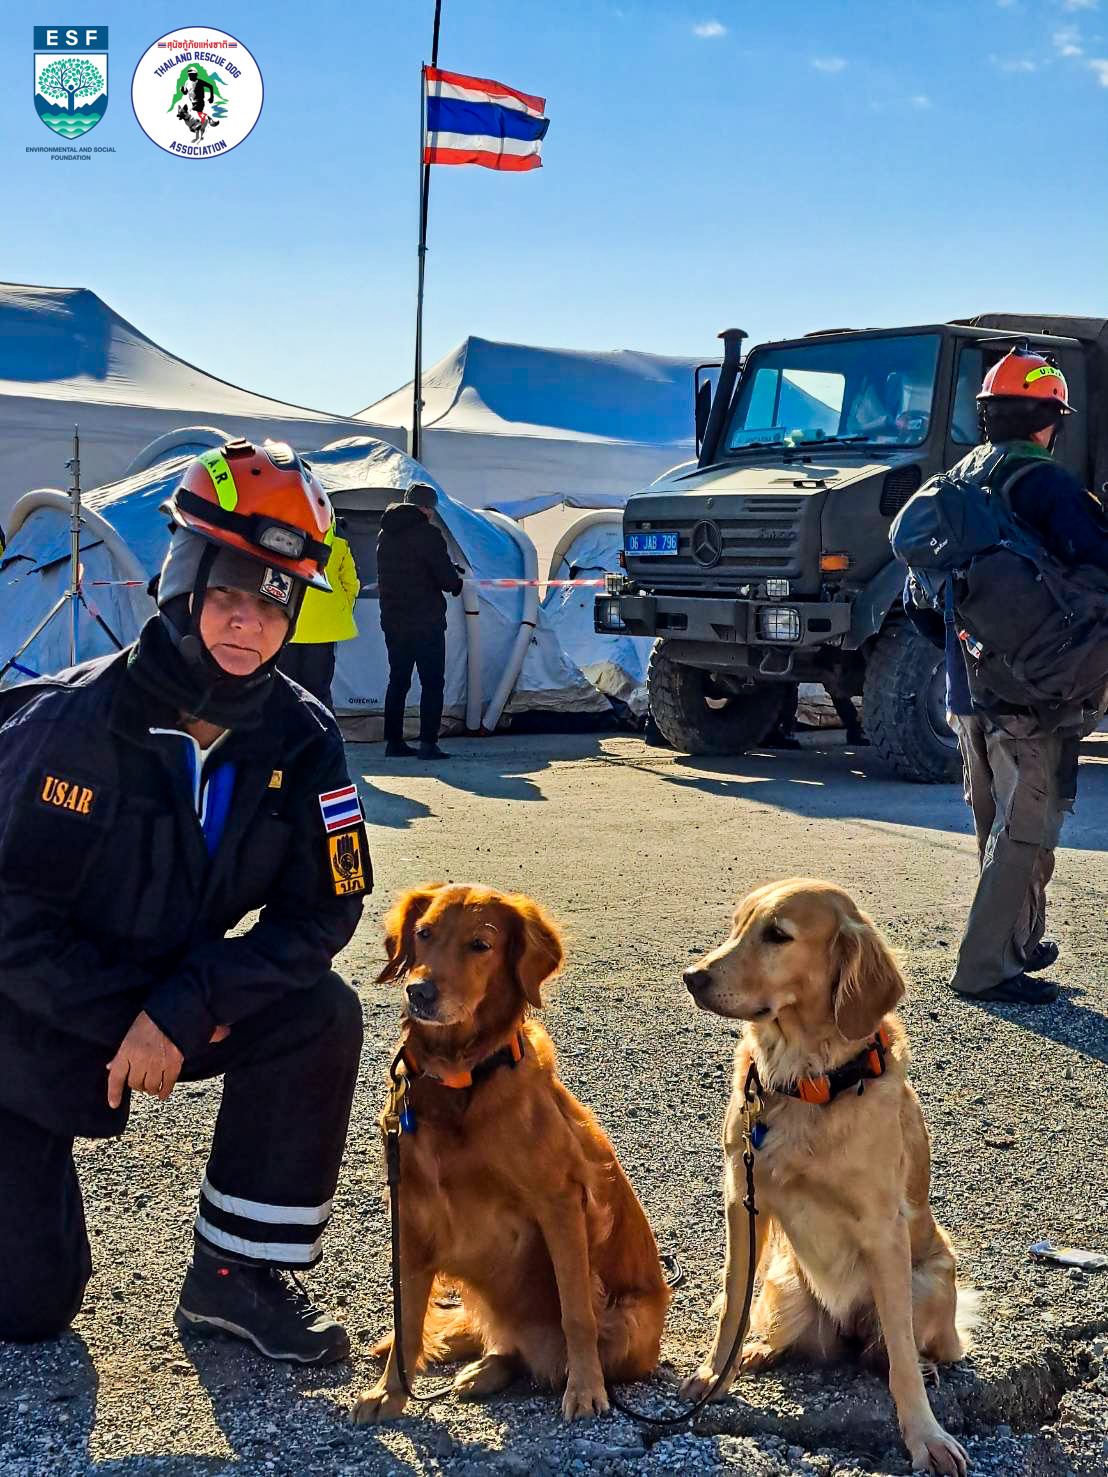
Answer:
[0,442,371,1363]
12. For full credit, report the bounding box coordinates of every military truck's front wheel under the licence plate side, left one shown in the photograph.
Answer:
[647,645,786,753]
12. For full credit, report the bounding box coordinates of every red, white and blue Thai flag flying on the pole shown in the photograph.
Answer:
[423,66,550,170]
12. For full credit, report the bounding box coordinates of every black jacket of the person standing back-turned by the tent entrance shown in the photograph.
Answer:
[377,502,462,632]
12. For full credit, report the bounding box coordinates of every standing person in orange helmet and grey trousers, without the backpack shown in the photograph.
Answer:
[906,350,1108,1004]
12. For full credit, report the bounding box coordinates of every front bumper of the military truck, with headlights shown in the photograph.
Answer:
[592,595,851,650]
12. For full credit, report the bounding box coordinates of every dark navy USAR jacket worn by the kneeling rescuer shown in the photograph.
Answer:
[0,651,371,1137]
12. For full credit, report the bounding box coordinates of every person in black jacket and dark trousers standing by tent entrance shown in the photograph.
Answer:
[377,483,462,759]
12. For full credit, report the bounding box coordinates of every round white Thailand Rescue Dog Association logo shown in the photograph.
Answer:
[131,25,263,160]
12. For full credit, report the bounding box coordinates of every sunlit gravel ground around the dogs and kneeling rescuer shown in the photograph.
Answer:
[0,736,1108,1477]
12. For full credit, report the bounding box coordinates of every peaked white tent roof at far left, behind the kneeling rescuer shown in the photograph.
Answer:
[0,284,381,524]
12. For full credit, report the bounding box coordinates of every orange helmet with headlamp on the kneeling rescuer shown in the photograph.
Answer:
[168,440,334,589]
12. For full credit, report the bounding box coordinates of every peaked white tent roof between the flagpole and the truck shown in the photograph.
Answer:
[359,338,696,517]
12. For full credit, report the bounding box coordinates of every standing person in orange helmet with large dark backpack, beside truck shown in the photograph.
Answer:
[891,349,1108,1004]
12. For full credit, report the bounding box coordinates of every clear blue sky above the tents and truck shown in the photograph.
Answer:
[0,0,1108,412]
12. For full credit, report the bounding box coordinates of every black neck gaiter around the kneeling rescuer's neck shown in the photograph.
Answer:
[127,610,276,730]
